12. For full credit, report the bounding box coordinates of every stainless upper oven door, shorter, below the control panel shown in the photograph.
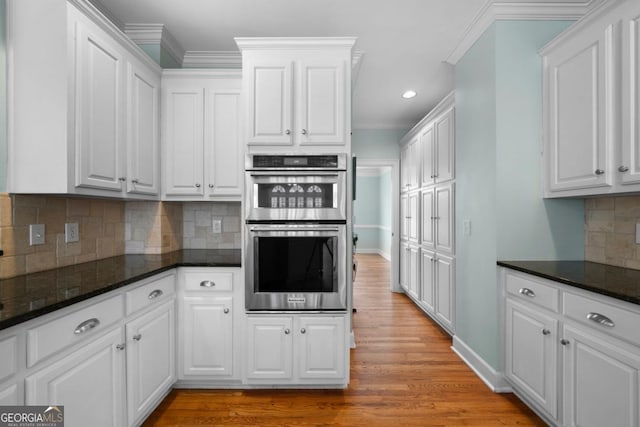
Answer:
[245,171,347,221]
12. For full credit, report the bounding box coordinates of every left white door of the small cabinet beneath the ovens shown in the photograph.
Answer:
[247,317,293,381]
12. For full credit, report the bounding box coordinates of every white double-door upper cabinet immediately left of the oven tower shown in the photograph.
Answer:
[162,70,243,200]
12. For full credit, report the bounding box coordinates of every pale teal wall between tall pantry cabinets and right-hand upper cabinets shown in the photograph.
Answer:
[455,21,584,369]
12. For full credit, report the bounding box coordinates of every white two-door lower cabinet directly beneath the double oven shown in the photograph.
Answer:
[246,315,348,386]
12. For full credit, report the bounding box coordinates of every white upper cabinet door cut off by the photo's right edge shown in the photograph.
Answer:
[618,1,640,184]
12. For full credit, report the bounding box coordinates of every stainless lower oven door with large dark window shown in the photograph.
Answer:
[245,224,347,311]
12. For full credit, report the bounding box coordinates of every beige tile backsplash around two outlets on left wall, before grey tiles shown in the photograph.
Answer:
[0,193,125,278]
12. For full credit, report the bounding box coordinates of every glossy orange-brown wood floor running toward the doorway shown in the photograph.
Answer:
[144,254,545,427]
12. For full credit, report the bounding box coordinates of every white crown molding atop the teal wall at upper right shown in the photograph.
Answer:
[445,0,605,65]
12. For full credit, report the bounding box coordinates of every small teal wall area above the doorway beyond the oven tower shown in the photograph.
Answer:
[351,129,408,159]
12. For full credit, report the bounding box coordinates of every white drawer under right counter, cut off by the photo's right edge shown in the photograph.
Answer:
[563,292,640,345]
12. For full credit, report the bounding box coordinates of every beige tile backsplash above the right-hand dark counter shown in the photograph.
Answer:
[584,196,640,269]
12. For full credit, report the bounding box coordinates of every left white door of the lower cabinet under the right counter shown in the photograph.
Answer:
[505,298,559,419]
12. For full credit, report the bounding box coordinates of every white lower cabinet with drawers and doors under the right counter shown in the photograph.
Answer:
[502,269,640,427]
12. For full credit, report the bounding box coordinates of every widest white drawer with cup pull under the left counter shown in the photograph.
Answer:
[27,295,124,367]
